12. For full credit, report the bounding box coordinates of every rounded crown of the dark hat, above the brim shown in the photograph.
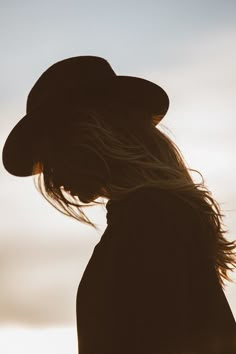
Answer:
[26,56,116,113]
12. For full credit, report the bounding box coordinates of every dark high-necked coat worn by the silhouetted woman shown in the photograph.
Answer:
[77,188,236,354]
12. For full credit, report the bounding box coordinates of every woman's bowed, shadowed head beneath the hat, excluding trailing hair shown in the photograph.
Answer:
[34,103,190,210]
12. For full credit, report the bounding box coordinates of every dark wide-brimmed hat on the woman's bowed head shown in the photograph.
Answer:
[2,56,169,177]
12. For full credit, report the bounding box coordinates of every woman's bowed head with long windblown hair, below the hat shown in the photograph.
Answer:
[35,102,236,287]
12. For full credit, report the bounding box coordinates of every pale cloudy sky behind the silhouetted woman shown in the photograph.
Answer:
[0,0,236,354]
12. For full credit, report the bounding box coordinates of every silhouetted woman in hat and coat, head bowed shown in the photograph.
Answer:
[3,56,236,354]
